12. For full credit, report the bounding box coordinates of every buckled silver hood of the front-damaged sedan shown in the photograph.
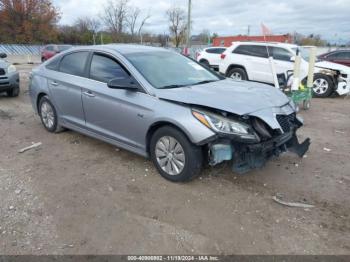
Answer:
[156,79,289,115]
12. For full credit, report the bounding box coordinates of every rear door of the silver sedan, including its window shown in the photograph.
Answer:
[48,51,89,127]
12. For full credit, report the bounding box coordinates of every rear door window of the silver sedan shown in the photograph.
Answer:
[59,51,89,76]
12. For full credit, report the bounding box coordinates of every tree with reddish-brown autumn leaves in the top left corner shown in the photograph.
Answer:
[0,0,60,43]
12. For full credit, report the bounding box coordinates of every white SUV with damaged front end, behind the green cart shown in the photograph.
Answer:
[219,42,350,97]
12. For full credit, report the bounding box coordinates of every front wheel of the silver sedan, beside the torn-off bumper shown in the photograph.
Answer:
[150,126,203,182]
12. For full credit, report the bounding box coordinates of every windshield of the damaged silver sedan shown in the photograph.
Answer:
[125,51,220,88]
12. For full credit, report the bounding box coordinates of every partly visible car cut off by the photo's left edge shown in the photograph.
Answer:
[0,53,19,97]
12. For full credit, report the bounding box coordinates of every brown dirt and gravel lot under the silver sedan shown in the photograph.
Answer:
[0,66,350,254]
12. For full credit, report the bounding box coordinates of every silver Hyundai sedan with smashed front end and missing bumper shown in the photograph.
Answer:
[30,45,310,182]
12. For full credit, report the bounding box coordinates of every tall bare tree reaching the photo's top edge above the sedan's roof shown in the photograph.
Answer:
[101,0,129,38]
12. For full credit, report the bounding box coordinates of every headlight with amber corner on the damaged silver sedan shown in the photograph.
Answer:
[192,110,257,139]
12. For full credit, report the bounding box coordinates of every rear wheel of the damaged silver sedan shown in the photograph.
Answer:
[38,96,63,133]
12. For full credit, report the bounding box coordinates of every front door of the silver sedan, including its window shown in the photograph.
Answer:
[82,53,154,150]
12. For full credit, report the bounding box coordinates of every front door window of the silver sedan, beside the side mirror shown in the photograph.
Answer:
[90,54,129,83]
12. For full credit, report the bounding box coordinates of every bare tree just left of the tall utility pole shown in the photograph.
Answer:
[167,6,186,47]
